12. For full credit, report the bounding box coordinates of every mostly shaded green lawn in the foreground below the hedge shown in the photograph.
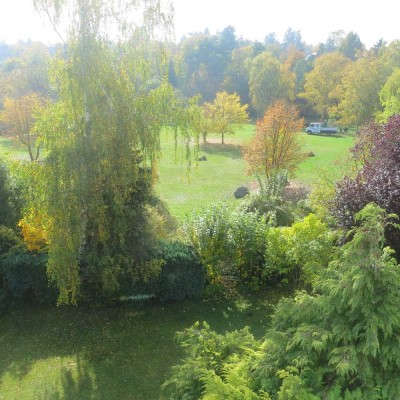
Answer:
[0,292,278,400]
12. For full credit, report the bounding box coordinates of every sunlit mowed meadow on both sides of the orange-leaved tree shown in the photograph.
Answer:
[157,125,354,218]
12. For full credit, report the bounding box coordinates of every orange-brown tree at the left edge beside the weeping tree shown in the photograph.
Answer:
[0,93,45,161]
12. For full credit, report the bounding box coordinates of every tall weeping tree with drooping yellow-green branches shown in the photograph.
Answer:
[34,0,200,304]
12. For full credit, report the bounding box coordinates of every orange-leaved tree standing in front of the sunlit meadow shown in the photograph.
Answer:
[244,100,305,194]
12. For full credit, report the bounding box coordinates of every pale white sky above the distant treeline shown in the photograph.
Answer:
[0,0,400,48]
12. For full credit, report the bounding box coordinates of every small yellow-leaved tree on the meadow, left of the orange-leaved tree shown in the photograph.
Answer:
[204,92,249,143]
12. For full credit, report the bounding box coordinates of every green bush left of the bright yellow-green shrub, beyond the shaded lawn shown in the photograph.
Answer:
[183,204,268,286]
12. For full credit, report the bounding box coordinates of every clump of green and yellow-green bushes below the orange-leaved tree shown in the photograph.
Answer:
[184,200,334,289]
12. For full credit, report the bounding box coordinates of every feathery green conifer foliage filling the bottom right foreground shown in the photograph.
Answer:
[164,204,400,400]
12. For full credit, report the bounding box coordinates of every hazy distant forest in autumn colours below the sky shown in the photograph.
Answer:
[0,26,400,127]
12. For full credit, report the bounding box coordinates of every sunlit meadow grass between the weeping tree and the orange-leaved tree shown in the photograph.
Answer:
[157,125,255,217]
